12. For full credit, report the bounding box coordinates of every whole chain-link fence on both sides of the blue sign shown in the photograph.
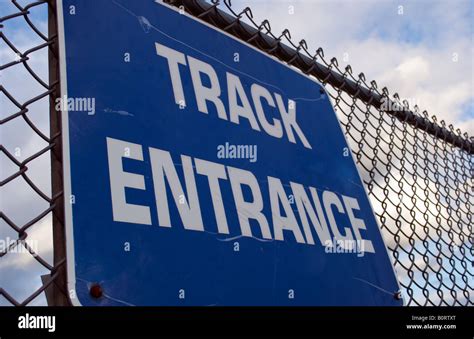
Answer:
[0,0,474,306]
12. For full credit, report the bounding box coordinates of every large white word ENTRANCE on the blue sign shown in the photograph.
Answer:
[107,138,375,253]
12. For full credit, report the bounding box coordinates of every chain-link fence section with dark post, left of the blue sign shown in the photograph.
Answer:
[0,0,66,306]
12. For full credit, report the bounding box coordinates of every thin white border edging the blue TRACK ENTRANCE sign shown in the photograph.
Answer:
[57,0,405,306]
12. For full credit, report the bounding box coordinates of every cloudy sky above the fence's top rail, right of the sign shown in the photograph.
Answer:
[233,0,474,135]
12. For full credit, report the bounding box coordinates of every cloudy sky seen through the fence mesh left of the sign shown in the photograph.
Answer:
[0,8,53,305]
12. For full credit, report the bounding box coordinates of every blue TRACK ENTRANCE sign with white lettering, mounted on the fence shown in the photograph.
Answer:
[57,0,401,306]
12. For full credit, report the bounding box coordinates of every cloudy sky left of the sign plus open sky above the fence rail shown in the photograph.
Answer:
[0,0,474,305]
